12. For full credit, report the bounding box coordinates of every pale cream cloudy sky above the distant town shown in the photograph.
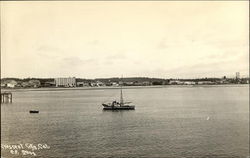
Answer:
[0,1,249,78]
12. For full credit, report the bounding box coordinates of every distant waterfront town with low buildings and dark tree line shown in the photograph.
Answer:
[1,72,249,88]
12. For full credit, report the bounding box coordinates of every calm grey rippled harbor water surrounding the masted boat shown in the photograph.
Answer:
[1,85,249,158]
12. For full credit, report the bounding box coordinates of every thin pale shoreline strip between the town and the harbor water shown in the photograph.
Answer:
[1,84,249,92]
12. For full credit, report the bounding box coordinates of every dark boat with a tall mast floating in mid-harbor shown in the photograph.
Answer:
[102,78,135,110]
